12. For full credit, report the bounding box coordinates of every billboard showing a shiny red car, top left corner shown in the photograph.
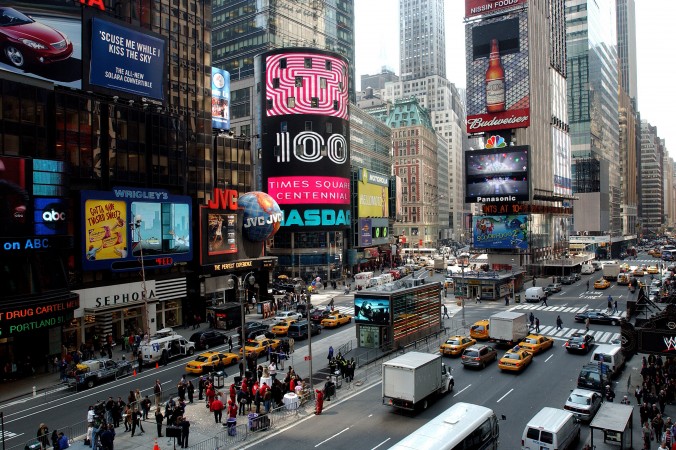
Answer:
[0,0,82,89]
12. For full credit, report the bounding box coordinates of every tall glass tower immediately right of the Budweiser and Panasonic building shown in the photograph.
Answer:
[566,0,626,243]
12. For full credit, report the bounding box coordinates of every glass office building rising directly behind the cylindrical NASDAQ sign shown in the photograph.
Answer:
[211,0,356,135]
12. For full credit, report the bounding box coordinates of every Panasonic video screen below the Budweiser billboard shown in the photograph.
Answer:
[465,145,530,203]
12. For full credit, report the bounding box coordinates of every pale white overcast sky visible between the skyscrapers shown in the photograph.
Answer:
[355,0,676,155]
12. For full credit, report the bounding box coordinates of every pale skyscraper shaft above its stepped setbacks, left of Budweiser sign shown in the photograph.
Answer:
[399,0,446,81]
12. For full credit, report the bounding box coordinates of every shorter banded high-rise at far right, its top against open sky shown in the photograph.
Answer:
[640,120,665,232]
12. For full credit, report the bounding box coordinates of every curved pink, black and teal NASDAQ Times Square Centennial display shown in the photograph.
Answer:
[255,48,351,231]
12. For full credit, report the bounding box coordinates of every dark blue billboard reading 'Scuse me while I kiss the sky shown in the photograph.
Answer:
[89,18,165,100]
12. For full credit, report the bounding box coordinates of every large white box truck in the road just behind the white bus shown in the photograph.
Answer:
[383,352,454,411]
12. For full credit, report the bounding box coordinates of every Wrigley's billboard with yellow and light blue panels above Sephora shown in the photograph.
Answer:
[81,188,192,271]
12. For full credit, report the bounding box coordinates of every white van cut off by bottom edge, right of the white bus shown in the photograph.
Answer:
[521,407,580,450]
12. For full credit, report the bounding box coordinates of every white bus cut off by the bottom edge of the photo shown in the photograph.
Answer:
[390,403,500,450]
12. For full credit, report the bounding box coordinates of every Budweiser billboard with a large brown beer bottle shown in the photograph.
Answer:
[465,11,530,133]
